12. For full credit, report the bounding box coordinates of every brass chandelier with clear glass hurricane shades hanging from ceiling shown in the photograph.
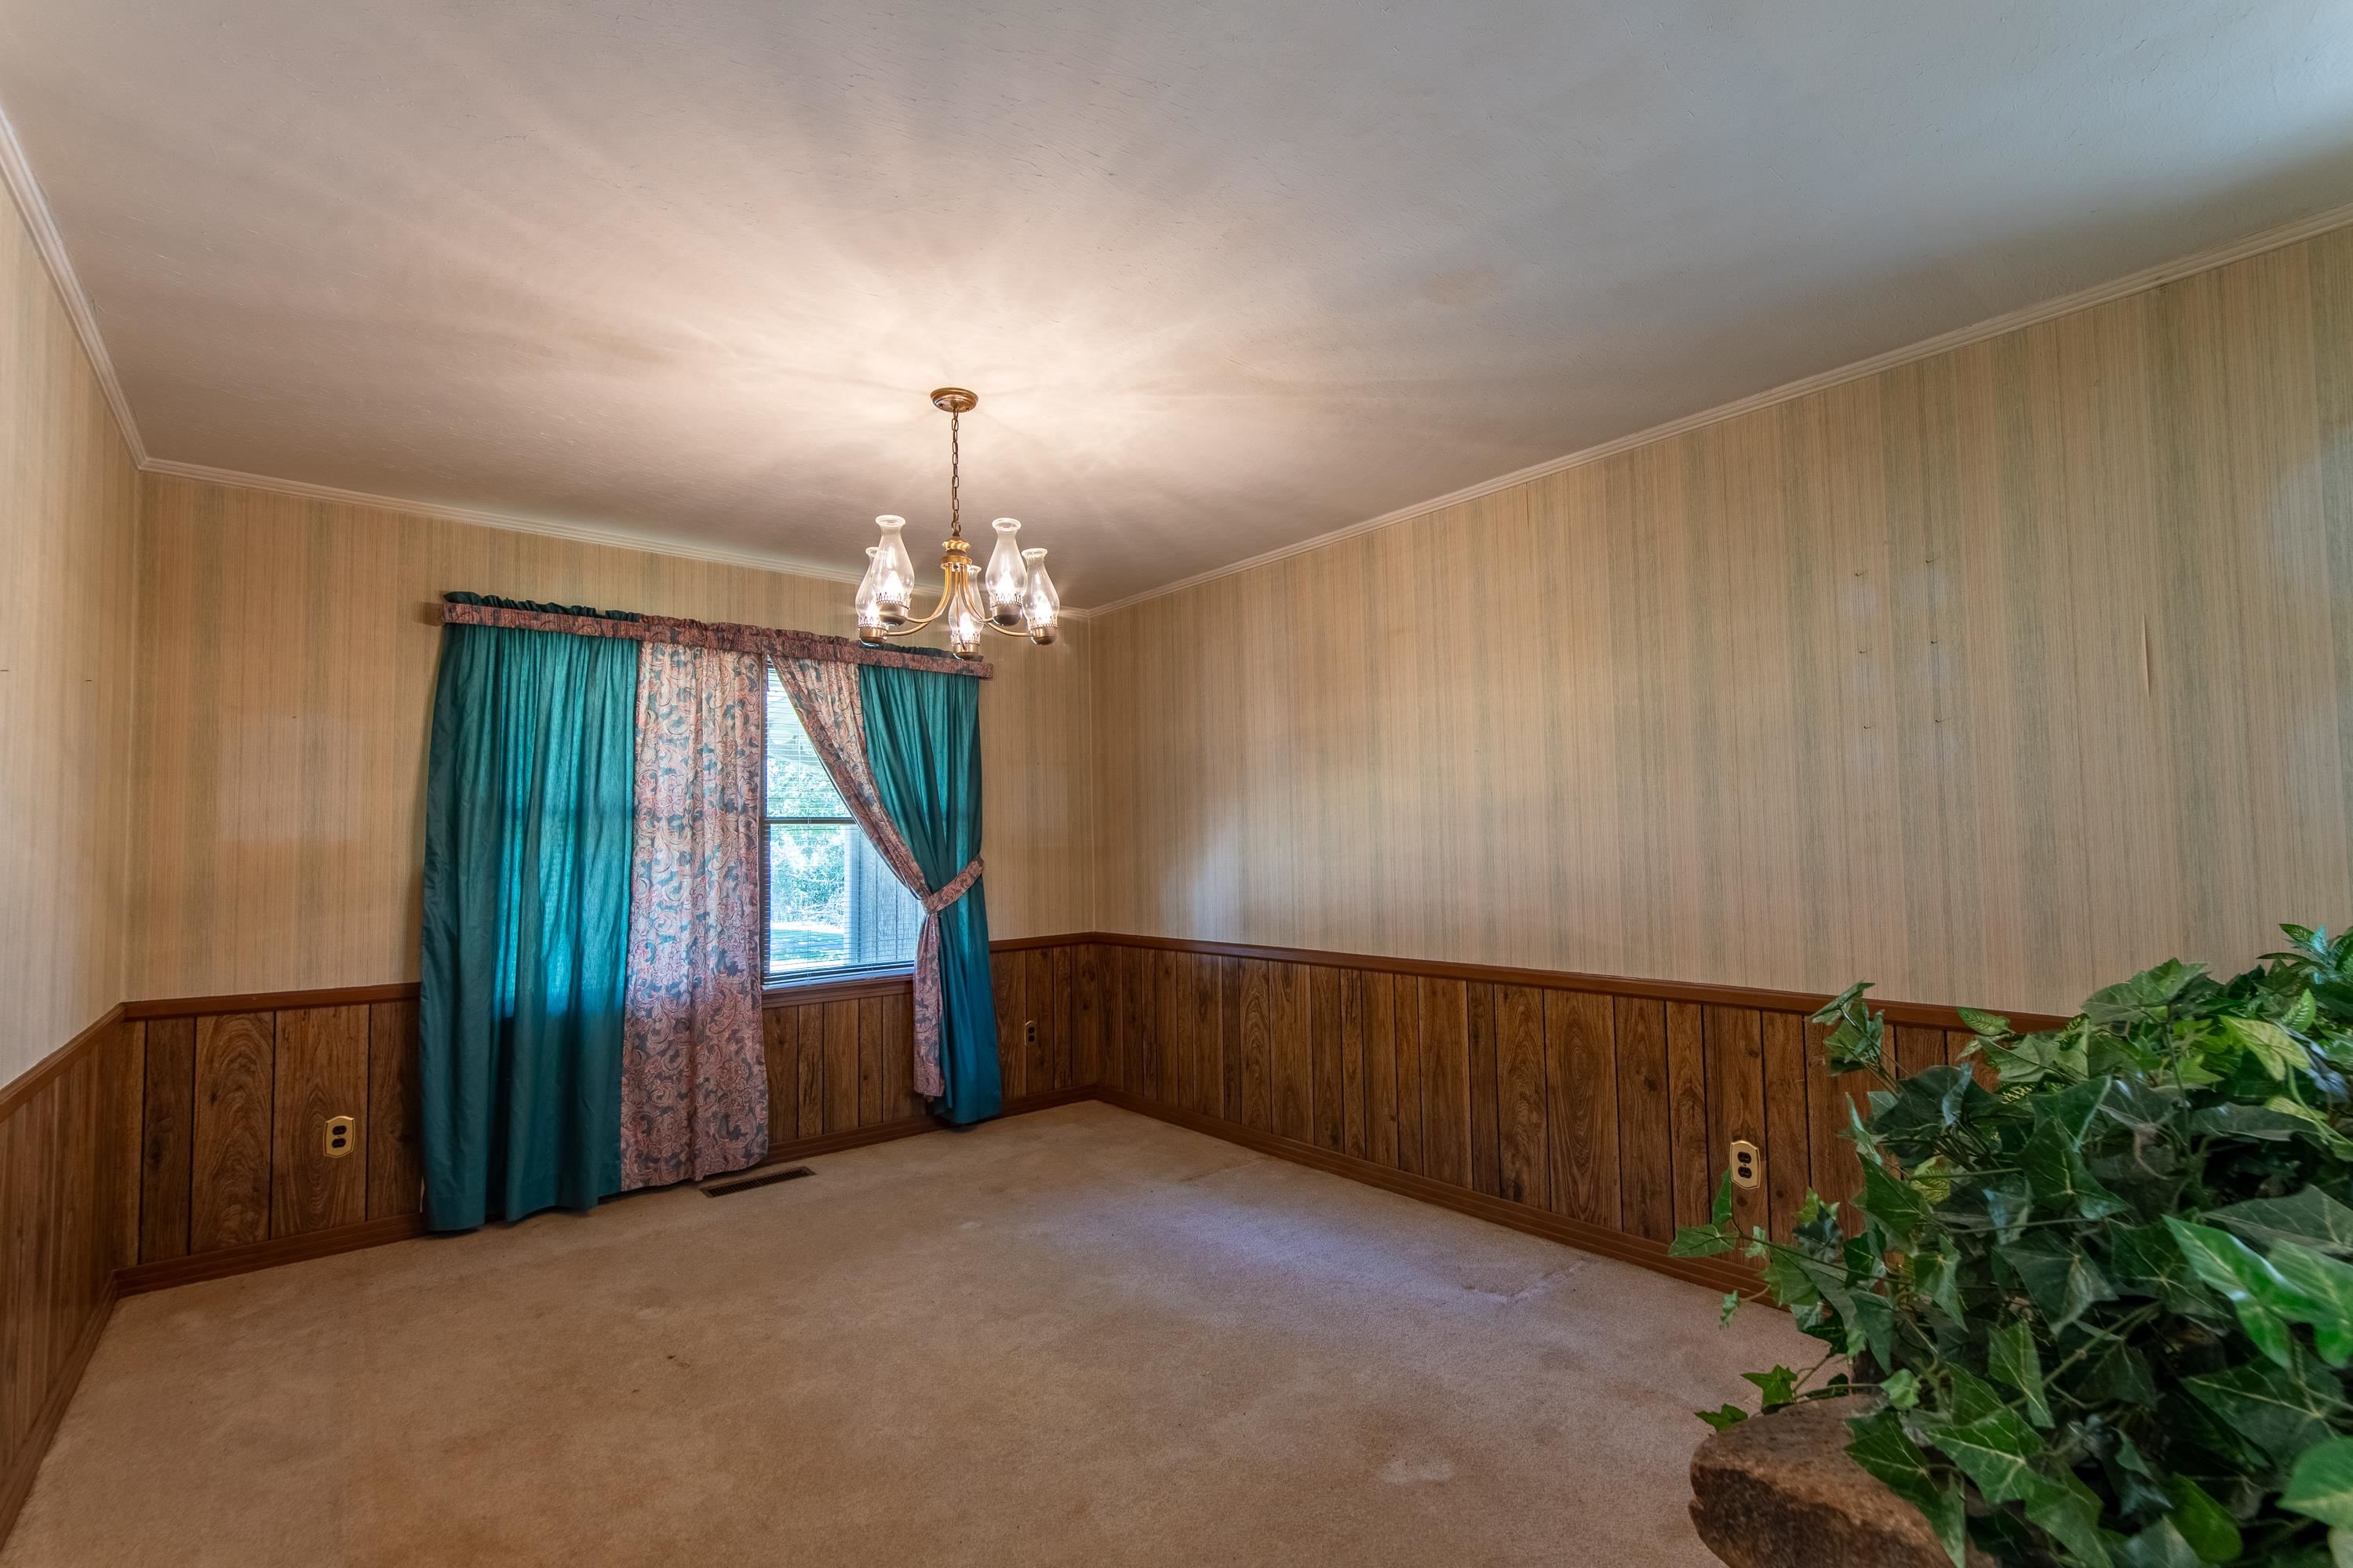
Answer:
[857,386,1062,658]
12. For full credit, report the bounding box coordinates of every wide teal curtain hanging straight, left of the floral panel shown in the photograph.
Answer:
[419,595,638,1229]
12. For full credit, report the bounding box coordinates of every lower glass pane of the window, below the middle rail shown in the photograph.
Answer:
[767,823,923,976]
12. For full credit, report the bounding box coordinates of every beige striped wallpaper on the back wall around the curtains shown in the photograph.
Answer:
[129,475,1092,997]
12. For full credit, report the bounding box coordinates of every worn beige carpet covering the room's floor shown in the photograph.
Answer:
[0,1105,1805,1568]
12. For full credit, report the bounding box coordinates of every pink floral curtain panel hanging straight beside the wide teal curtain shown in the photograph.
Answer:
[621,642,767,1189]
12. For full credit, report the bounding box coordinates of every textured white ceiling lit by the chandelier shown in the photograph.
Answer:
[0,0,2353,606]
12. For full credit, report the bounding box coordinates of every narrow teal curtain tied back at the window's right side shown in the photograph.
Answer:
[859,665,1005,1122]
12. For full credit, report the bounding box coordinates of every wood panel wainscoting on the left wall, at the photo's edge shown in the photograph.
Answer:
[0,1006,141,1540]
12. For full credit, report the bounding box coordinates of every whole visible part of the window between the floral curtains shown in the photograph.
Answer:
[767,670,923,983]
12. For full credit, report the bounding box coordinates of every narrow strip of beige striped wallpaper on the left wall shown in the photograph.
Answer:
[0,175,139,1084]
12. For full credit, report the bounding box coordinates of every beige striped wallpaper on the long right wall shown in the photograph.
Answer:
[1092,231,2353,1024]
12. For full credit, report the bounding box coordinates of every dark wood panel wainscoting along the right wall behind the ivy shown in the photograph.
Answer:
[1073,933,2056,1288]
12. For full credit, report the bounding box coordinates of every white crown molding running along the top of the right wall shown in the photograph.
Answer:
[1087,202,2353,616]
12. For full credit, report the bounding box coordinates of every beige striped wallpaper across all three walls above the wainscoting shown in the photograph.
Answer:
[32,202,2353,1029]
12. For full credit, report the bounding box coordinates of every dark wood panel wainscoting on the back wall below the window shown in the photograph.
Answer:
[122,938,1097,1293]
